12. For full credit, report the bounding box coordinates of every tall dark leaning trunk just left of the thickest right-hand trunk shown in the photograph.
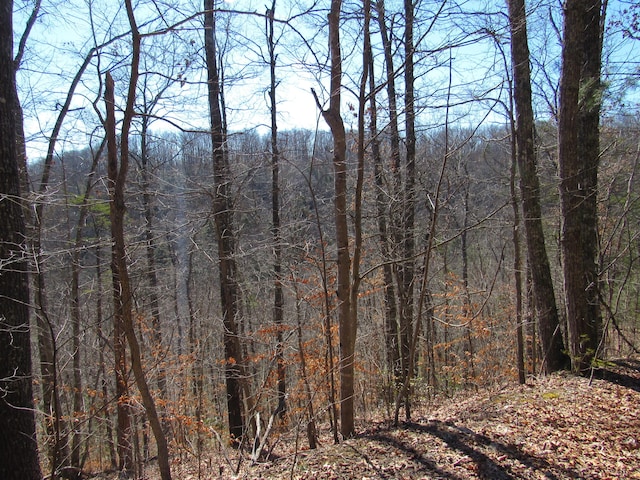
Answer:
[508,0,567,373]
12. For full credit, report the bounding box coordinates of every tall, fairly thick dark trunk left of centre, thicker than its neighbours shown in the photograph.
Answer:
[204,0,245,446]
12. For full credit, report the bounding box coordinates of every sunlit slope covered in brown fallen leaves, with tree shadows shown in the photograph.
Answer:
[89,360,640,480]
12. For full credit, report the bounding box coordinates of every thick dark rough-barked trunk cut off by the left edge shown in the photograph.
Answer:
[0,1,42,480]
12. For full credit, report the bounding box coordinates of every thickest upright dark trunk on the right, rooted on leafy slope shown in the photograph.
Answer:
[558,0,602,373]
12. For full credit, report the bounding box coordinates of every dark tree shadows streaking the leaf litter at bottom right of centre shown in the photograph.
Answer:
[363,421,584,480]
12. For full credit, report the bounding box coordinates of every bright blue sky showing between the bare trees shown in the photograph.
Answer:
[14,0,640,159]
